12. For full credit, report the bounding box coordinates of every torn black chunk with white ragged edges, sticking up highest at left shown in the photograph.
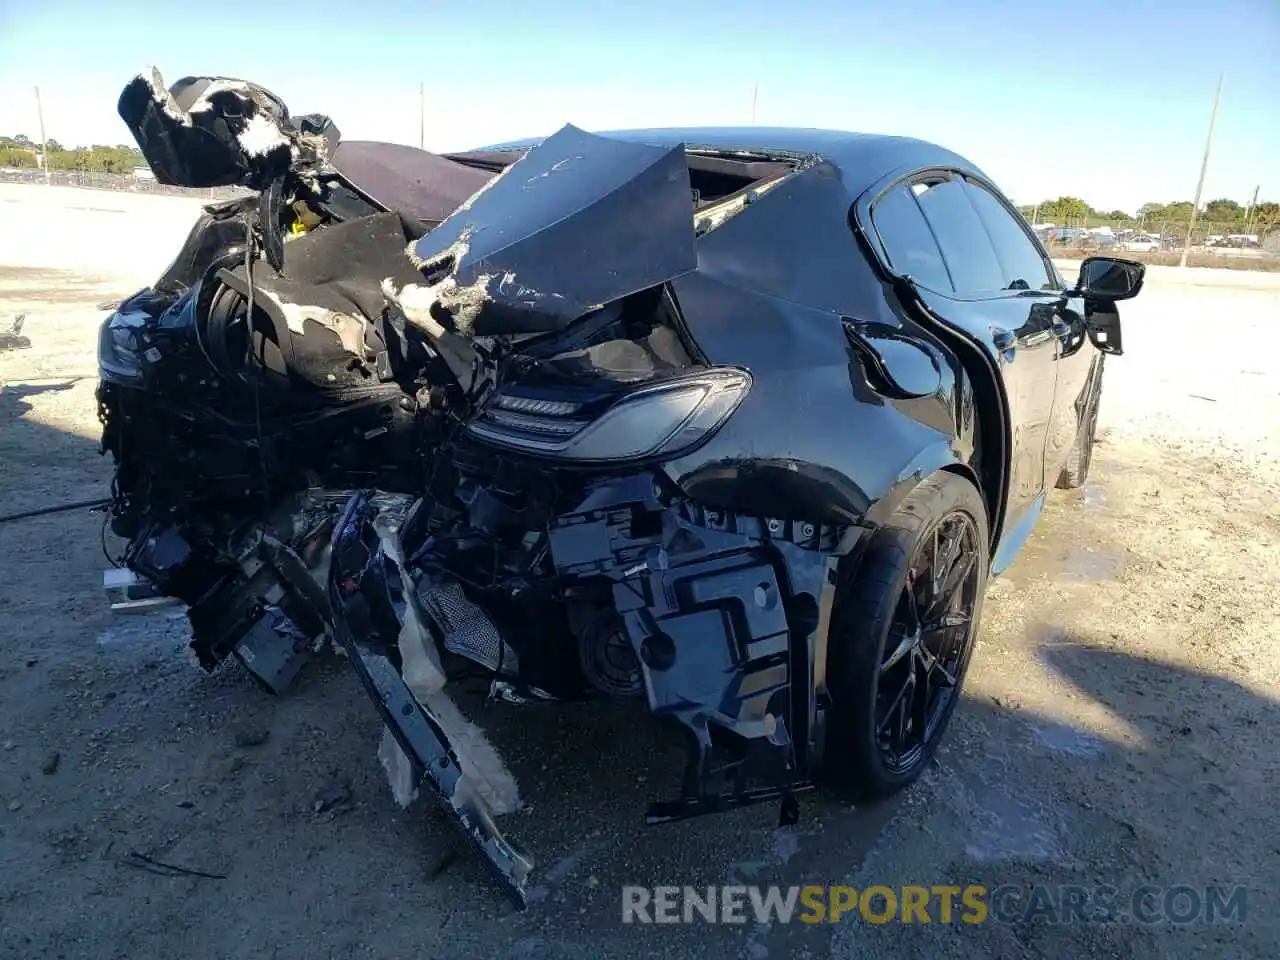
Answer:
[116,68,339,188]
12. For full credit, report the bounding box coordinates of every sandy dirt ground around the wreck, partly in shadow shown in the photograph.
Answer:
[0,188,1280,960]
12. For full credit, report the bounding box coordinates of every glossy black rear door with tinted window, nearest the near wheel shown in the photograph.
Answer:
[869,170,1061,555]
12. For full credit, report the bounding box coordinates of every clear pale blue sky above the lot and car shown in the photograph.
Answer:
[0,0,1280,209]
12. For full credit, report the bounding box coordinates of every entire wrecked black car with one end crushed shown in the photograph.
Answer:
[100,69,1143,902]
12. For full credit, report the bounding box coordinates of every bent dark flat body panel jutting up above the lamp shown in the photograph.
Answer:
[407,125,698,337]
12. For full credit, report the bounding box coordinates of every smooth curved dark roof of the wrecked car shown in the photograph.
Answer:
[465,127,986,192]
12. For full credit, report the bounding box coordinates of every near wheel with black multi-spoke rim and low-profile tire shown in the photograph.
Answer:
[823,471,989,801]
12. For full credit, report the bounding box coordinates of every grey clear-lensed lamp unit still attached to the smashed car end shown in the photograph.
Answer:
[467,367,751,462]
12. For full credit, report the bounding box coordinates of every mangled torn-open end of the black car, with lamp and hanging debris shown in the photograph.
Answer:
[99,67,864,902]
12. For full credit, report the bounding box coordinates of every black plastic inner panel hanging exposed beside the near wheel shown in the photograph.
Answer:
[549,475,856,822]
